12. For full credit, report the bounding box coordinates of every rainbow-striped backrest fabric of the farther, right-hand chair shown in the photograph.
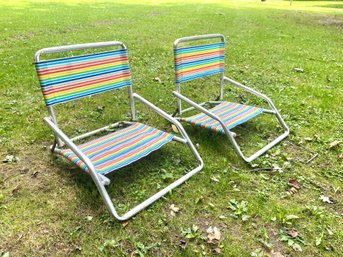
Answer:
[174,42,225,83]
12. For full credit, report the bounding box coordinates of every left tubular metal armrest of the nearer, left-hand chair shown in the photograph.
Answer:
[44,117,96,175]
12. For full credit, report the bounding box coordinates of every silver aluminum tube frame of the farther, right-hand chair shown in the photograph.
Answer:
[172,34,289,162]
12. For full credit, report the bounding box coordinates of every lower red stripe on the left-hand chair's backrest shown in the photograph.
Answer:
[43,72,131,95]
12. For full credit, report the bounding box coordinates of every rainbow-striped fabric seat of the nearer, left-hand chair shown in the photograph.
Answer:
[60,123,174,174]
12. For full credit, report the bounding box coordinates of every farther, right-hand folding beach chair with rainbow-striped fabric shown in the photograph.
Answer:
[173,34,289,162]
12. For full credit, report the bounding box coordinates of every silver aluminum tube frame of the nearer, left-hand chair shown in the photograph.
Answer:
[34,41,204,221]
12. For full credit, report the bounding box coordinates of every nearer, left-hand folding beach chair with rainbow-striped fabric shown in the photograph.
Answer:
[35,41,203,220]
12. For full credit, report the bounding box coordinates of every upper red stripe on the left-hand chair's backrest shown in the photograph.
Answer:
[38,56,128,76]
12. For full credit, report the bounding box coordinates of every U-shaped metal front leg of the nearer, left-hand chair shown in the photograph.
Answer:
[88,141,204,221]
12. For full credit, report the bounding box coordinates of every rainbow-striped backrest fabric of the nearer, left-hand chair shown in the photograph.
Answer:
[36,49,131,106]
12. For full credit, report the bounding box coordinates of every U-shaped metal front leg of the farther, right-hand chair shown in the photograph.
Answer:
[228,111,289,162]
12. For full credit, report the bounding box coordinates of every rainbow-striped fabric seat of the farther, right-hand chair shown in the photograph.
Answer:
[181,101,263,134]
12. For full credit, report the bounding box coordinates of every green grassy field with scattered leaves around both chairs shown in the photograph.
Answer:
[0,0,343,257]
